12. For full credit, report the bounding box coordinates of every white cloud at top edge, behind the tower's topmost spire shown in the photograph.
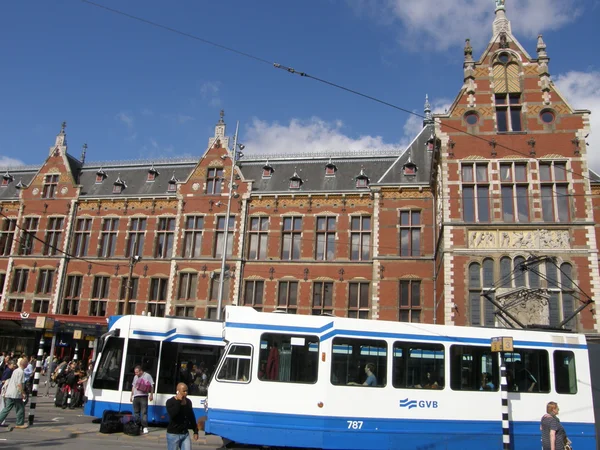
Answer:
[349,0,581,51]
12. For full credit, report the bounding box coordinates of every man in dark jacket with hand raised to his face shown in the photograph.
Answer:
[167,383,198,450]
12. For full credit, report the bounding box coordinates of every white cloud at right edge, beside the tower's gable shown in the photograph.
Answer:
[554,71,600,172]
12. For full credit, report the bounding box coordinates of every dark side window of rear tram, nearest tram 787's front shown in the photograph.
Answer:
[156,342,223,395]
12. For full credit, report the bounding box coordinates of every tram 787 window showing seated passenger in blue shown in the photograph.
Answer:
[331,337,387,387]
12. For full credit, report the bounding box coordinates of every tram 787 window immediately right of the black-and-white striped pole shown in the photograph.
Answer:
[504,349,550,393]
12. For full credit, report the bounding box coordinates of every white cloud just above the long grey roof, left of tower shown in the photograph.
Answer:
[244,117,403,154]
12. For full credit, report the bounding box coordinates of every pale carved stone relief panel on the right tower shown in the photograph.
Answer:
[469,230,571,250]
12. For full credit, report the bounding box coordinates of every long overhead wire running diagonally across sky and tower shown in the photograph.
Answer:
[80,0,593,185]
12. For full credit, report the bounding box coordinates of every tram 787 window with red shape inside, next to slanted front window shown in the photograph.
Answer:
[258,333,319,383]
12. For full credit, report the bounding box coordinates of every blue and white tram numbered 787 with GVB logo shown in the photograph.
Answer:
[205,306,596,450]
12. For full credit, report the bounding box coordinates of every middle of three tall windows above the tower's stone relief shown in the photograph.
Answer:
[500,163,529,222]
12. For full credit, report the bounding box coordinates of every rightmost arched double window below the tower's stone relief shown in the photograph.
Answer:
[546,261,576,329]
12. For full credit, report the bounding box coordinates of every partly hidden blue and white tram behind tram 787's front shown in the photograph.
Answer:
[84,316,225,423]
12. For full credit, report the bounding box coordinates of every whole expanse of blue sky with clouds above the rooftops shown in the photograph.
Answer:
[0,0,600,169]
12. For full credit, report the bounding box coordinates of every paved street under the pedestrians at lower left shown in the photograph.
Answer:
[0,381,222,450]
